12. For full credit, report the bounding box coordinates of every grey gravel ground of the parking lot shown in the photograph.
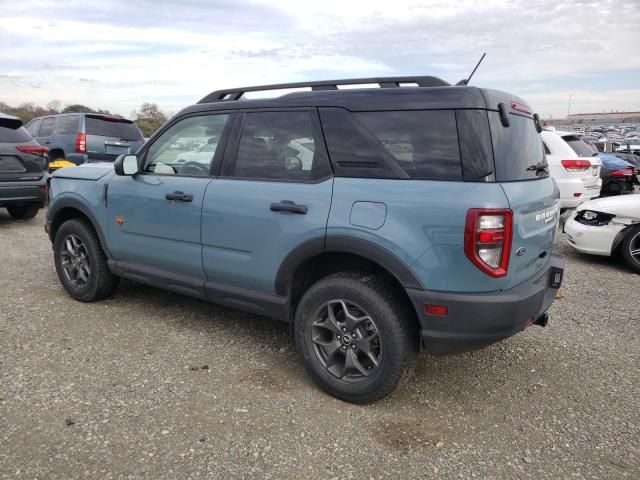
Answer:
[0,210,640,480]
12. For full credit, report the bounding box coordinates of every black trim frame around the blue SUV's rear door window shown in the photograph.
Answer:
[219,107,333,184]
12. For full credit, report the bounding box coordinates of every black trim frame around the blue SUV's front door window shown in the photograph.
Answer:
[138,110,237,179]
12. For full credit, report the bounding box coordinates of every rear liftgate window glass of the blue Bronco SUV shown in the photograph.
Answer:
[489,112,549,182]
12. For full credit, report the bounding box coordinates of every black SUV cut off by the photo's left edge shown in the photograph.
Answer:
[0,113,49,220]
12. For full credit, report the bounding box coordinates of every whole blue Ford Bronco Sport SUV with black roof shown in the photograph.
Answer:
[46,77,564,403]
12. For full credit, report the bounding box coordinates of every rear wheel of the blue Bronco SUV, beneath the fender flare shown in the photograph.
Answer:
[294,273,417,403]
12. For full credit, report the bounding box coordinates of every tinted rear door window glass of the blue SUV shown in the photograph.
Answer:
[235,111,322,181]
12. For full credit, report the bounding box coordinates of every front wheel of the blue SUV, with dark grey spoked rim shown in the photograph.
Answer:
[53,219,119,302]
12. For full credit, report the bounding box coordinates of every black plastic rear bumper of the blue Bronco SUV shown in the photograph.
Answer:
[407,254,564,354]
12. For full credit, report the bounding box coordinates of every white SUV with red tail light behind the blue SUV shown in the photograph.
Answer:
[541,129,602,210]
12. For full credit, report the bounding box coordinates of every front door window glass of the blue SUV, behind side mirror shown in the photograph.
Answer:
[144,114,229,176]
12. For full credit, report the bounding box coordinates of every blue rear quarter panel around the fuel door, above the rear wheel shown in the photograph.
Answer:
[327,178,509,292]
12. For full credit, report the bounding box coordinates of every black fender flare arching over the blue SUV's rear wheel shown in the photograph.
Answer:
[275,235,424,296]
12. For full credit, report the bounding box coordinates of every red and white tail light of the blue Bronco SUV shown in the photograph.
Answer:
[464,208,513,278]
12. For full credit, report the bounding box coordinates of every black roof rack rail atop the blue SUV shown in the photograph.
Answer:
[198,76,451,103]
